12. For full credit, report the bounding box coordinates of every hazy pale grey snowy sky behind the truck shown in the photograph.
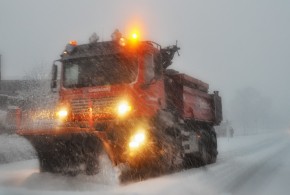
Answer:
[0,0,290,133]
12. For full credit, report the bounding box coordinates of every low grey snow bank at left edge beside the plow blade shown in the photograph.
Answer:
[0,134,36,164]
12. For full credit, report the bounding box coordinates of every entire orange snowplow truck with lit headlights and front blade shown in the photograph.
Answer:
[18,31,222,175]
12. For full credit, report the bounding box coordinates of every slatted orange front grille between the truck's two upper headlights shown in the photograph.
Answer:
[71,97,117,114]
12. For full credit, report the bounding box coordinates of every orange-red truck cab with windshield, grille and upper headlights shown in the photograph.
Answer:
[52,35,165,126]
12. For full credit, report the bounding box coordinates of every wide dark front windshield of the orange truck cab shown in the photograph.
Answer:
[63,54,138,88]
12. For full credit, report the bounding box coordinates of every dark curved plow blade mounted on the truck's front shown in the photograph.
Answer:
[17,128,103,175]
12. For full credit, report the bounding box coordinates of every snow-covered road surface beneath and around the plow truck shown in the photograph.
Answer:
[0,132,290,195]
